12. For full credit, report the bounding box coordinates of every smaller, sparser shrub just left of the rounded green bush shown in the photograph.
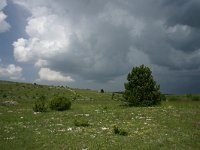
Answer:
[33,96,48,112]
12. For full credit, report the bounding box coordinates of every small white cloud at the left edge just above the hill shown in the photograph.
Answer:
[0,64,23,80]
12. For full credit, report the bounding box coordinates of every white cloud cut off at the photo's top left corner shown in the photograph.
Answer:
[0,0,10,33]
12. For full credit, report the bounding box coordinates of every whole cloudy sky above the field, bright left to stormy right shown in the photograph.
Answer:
[0,0,200,93]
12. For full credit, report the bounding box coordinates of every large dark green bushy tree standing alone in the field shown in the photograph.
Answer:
[124,65,161,106]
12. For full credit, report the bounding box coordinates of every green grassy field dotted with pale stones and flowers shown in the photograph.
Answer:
[0,81,200,150]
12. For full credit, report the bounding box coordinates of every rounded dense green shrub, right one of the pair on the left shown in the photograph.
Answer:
[49,96,71,111]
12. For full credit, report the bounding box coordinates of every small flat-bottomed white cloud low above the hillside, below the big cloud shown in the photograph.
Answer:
[38,68,74,82]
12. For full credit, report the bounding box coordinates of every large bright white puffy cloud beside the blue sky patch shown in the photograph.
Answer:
[13,10,70,62]
